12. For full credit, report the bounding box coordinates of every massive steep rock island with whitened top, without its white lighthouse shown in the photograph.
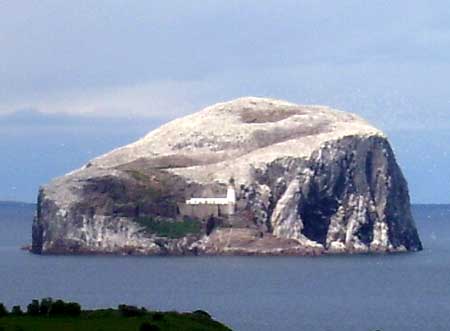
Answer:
[33,98,422,254]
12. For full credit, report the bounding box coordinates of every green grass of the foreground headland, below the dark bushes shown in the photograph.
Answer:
[0,309,230,331]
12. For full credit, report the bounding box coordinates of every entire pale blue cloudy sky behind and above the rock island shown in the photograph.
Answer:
[0,0,450,203]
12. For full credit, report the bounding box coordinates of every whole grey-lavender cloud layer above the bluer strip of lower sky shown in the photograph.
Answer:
[0,0,450,129]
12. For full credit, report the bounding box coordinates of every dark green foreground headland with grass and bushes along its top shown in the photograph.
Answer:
[0,298,230,331]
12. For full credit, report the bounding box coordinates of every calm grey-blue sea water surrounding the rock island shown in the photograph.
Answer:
[0,204,450,331]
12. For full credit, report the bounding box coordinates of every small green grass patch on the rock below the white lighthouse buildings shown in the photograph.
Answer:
[135,217,202,239]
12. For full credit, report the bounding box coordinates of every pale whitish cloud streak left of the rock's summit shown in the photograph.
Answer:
[3,81,215,118]
